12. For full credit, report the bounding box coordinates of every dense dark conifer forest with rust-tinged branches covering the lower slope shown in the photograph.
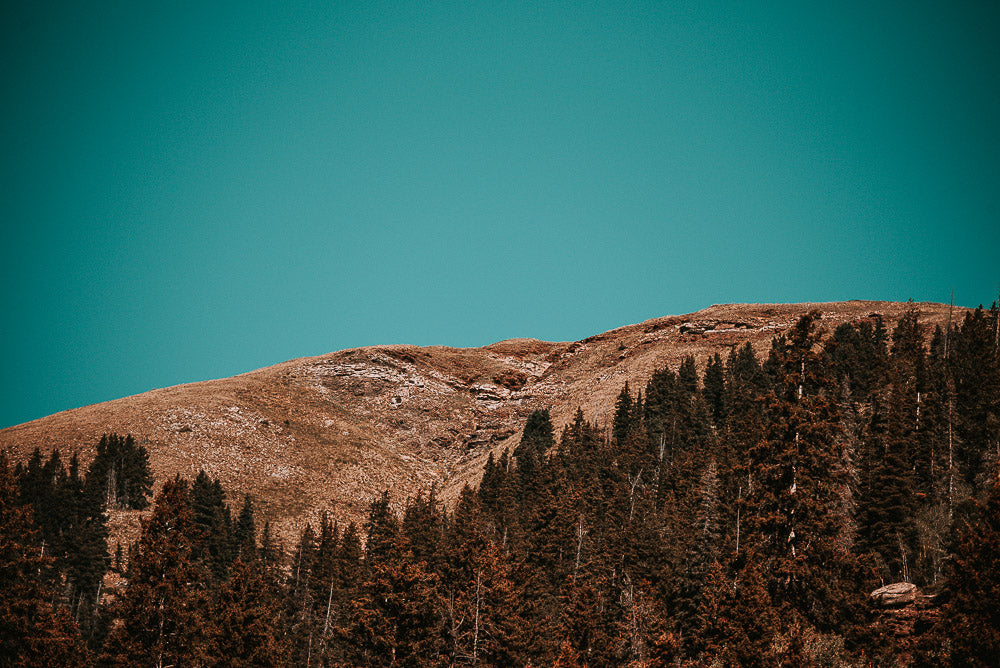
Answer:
[0,304,1000,668]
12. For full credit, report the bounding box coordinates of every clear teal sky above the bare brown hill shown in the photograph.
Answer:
[0,0,1000,426]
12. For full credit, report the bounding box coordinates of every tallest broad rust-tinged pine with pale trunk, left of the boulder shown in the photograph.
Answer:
[746,312,861,630]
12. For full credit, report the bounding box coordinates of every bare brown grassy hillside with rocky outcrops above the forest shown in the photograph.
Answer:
[0,301,964,542]
